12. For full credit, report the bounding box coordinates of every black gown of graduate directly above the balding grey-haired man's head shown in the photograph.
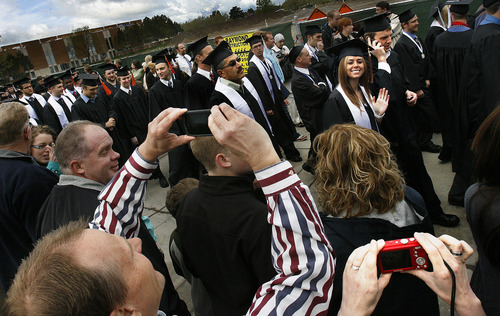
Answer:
[73,94,134,166]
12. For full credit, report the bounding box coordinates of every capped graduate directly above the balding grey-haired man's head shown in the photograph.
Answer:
[73,74,134,167]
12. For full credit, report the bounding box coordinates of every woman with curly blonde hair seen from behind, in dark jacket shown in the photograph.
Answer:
[314,124,439,315]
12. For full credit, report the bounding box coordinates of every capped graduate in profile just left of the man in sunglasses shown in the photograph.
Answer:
[185,36,215,110]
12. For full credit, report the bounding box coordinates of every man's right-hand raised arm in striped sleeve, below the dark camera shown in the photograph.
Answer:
[209,104,335,315]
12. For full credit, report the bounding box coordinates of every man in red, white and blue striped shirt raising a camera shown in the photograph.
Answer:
[8,104,335,315]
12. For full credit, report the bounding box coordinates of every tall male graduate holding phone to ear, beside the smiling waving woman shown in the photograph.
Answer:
[365,15,460,226]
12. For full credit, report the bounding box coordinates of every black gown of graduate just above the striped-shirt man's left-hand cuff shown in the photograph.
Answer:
[112,86,149,144]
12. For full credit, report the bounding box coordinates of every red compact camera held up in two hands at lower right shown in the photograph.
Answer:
[377,237,431,273]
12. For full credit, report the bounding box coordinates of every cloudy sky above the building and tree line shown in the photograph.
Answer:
[0,0,283,46]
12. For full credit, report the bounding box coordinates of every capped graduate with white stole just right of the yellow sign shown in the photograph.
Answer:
[245,35,302,162]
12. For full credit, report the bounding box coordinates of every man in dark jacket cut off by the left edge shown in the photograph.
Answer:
[0,102,58,293]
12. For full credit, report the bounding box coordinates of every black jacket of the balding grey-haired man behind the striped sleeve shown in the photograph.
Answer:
[37,185,189,316]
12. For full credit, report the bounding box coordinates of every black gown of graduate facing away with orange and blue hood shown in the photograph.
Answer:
[434,30,474,166]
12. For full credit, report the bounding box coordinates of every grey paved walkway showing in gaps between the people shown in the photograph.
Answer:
[144,128,477,315]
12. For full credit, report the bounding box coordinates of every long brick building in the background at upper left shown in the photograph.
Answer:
[0,20,142,79]
